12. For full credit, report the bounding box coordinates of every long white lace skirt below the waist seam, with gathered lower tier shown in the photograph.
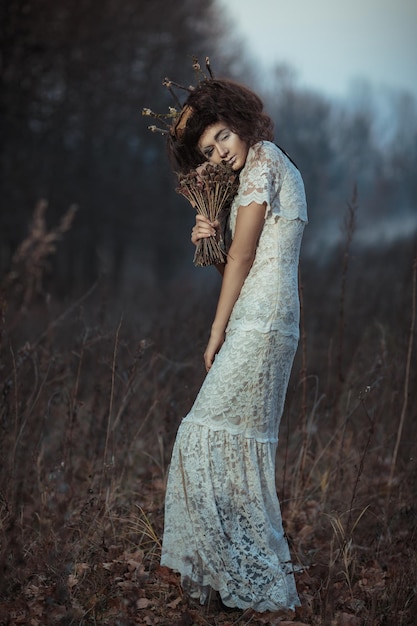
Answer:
[161,331,299,611]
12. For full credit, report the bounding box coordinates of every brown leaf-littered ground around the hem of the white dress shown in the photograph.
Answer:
[0,448,417,626]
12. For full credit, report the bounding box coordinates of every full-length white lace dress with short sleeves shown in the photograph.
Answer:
[161,142,307,611]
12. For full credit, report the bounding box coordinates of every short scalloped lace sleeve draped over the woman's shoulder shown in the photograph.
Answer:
[237,141,307,222]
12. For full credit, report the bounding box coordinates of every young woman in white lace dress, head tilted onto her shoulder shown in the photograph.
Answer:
[161,79,307,611]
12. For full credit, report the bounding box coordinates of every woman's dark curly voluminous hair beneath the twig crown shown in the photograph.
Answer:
[168,79,274,172]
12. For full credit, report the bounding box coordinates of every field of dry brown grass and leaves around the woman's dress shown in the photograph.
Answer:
[0,208,417,626]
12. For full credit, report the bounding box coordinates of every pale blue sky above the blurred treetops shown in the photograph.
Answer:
[218,0,417,97]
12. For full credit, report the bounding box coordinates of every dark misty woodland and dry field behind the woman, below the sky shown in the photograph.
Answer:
[0,0,417,626]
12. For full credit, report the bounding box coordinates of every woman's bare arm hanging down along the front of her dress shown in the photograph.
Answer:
[204,202,265,371]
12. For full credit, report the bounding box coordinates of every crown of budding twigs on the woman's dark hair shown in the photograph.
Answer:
[142,57,214,136]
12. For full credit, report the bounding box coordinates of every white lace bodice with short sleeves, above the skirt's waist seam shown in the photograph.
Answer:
[227,141,307,337]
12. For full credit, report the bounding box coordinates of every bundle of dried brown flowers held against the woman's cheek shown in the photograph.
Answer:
[176,162,239,267]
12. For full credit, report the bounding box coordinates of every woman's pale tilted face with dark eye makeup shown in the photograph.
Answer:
[198,122,249,171]
